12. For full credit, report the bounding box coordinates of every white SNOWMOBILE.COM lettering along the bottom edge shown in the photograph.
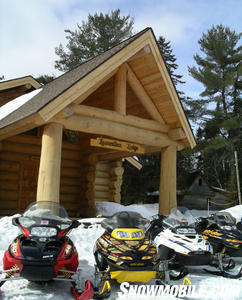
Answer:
[118,282,240,300]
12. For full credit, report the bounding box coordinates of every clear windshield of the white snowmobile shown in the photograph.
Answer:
[164,206,196,228]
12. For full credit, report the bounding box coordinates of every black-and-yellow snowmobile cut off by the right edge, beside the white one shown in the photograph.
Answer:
[197,212,242,257]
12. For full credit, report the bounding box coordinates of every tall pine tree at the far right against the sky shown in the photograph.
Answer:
[188,25,242,193]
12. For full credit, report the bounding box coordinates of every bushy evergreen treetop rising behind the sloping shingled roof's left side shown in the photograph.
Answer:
[55,9,134,71]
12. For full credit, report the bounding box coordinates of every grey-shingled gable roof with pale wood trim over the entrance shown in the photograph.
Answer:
[0,28,195,147]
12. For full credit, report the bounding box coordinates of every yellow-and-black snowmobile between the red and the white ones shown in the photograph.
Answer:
[94,211,169,286]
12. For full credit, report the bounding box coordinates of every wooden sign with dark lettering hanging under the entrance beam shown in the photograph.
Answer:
[90,137,145,154]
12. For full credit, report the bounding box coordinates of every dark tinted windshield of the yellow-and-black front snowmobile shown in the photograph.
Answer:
[101,211,149,232]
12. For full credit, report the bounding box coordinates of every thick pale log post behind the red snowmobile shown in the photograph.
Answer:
[37,123,63,202]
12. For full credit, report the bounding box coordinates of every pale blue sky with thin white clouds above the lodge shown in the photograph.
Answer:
[0,0,242,98]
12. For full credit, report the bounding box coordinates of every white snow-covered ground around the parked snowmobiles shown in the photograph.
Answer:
[0,202,242,300]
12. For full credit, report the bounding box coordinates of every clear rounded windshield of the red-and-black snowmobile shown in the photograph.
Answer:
[19,201,72,228]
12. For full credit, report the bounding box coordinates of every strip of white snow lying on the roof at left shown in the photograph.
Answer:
[0,88,42,120]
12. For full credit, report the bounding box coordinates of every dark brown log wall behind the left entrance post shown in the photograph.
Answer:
[0,135,88,217]
